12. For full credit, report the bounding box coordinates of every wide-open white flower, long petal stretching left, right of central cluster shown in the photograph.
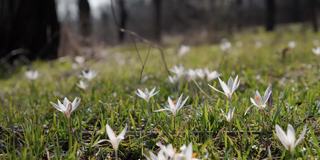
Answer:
[209,76,240,99]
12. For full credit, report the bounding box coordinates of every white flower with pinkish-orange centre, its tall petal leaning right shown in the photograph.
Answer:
[250,86,272,109]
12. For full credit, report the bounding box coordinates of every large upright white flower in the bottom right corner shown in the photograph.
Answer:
[276,124,307,152]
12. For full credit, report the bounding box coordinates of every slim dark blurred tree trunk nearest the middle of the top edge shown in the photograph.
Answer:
[153,0,162,42]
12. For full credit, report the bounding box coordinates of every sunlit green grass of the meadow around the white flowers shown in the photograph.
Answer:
[0,26,320,159]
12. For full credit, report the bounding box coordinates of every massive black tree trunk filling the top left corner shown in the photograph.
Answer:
[0,0,60,59]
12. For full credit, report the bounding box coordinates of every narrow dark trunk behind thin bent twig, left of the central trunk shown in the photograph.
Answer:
[117,0,128,42]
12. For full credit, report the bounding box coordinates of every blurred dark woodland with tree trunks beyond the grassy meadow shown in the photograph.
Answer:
[0,0,320,61]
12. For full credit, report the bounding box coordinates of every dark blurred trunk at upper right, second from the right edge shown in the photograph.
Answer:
[265,0,276,31]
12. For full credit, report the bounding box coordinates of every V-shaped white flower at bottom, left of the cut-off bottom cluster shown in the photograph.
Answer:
[106,124,128,151]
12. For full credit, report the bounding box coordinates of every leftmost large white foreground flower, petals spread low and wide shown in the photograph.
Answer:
[50,97,81,118]
